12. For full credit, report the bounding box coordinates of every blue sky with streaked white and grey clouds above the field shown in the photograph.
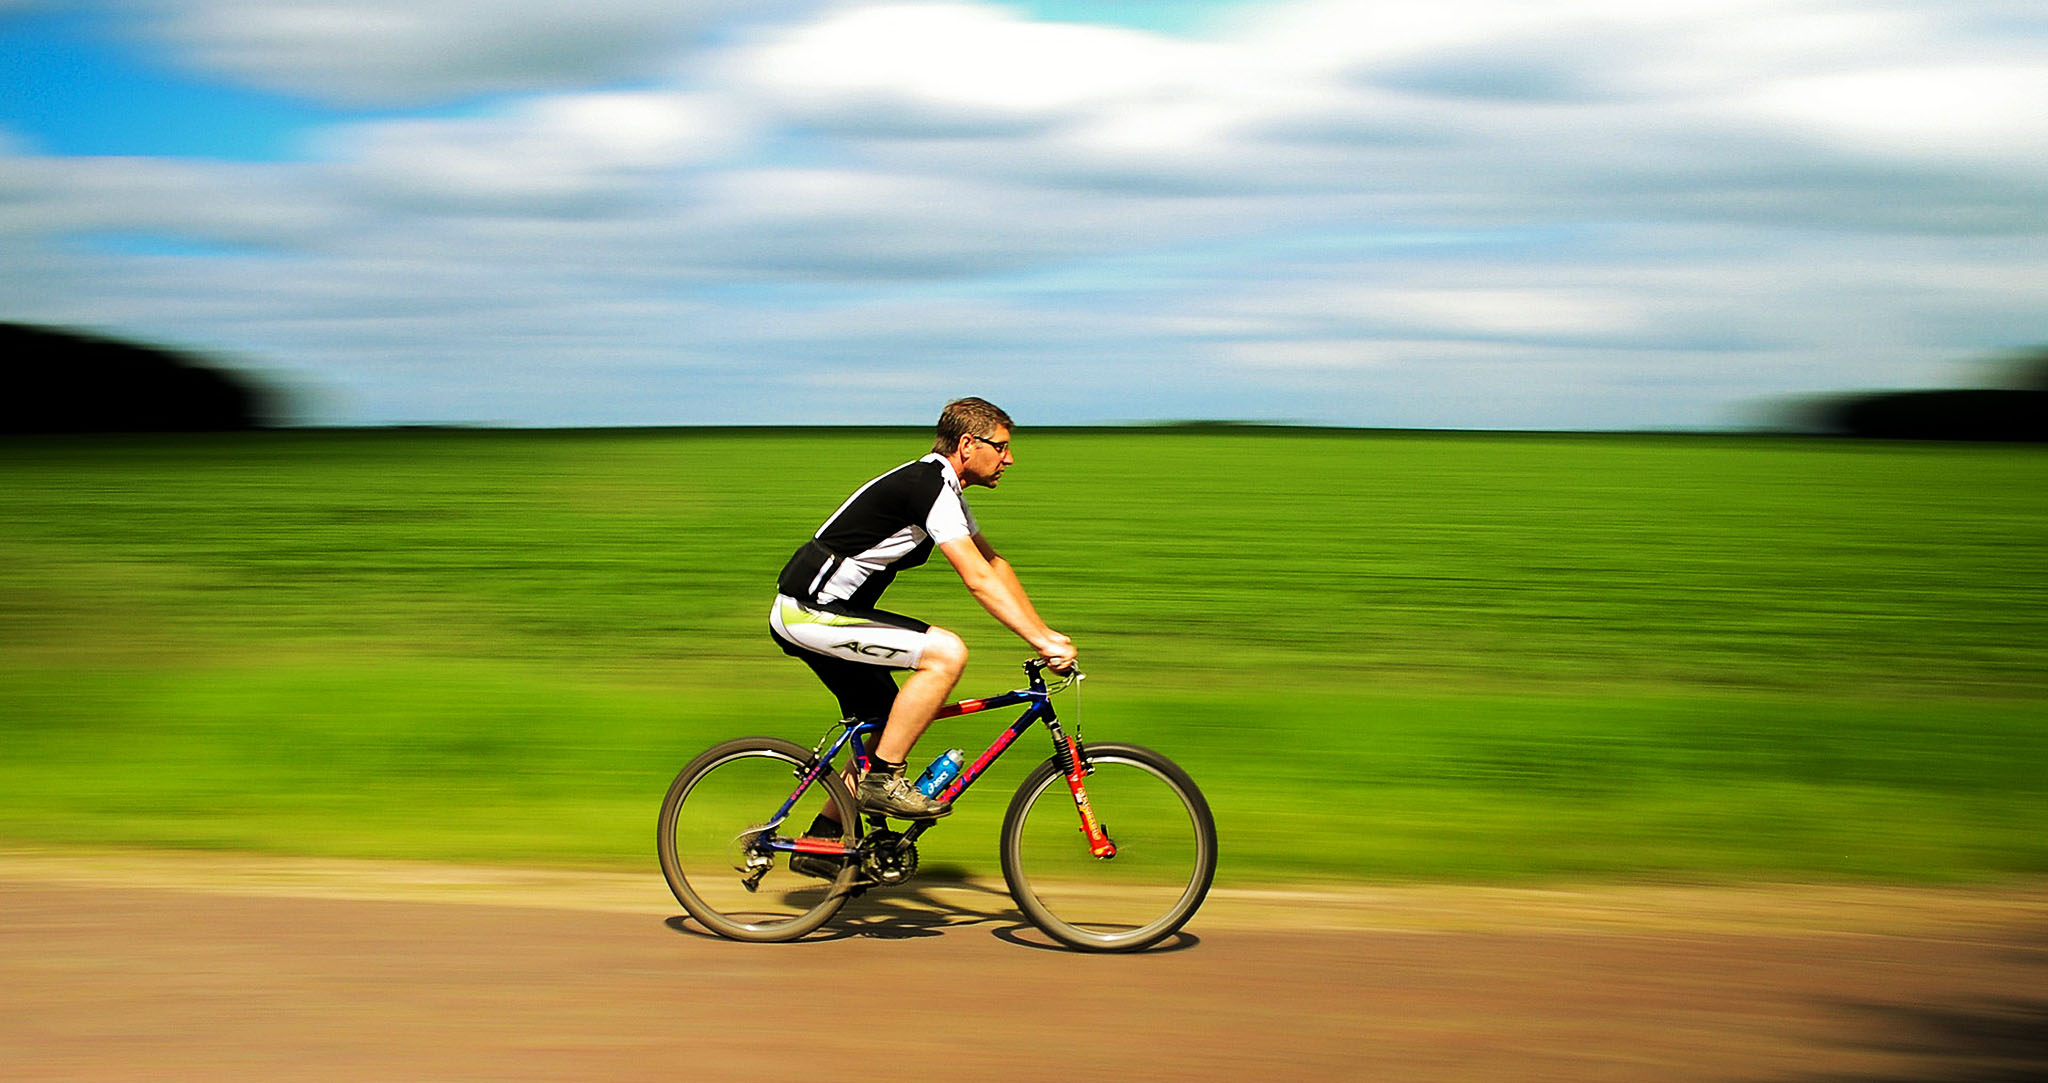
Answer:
[0,0,2048,430]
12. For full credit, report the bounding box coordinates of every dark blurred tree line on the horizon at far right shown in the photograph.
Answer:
[1808,350,2048,444]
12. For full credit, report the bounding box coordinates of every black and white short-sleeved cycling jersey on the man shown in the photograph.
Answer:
[776,452,981,610]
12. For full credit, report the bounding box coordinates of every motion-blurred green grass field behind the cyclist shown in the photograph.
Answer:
[0,428,2048,884]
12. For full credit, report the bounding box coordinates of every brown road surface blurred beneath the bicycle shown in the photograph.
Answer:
[0,852,2048,1083]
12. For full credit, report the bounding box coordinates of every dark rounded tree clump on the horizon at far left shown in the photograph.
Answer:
[0,323,283,432]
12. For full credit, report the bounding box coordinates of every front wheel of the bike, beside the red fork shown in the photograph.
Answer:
[1001,743,1217,952]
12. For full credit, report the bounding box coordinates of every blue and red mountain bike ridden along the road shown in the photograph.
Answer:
[655,659,1217,952]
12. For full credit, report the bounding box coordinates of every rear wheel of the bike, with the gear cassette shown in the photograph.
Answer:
[655,737,858,942]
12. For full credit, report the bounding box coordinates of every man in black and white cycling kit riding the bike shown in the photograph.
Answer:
[768,397,1075,837]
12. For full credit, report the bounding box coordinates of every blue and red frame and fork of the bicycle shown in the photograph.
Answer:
[766,659,1116,860]
